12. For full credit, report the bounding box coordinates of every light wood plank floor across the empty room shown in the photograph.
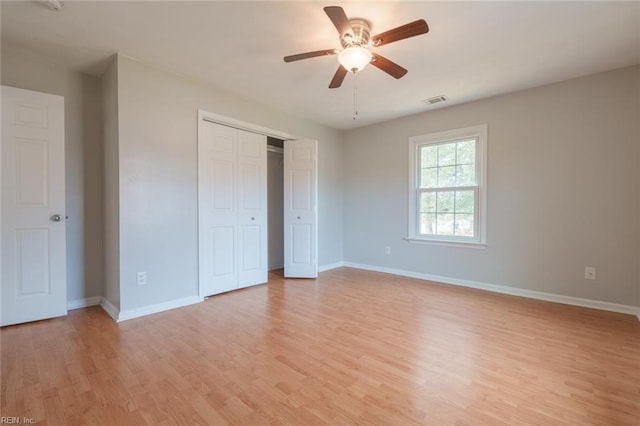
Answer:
[0,268,640,425]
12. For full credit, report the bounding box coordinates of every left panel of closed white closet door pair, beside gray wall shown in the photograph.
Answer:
[198,122,238,296]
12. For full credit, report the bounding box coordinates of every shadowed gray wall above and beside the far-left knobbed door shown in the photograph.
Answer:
[0,41,103,305]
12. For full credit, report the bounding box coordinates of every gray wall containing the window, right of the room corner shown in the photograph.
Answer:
[344,66,640,306]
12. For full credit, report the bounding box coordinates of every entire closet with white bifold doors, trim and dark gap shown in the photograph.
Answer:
[198,110,318,298]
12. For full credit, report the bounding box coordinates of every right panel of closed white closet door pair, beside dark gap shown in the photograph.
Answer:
[238,130,268,287]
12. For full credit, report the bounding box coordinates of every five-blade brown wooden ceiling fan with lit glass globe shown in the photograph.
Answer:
[284,6,429,89]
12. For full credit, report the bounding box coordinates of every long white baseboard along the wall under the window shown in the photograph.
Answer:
[344,262,640,320]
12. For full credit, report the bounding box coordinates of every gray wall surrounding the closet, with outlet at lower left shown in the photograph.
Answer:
[107,57,343,311]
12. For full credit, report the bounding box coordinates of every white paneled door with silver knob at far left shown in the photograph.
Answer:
[0,86,67,326]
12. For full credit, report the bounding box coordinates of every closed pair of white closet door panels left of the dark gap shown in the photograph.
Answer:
[198,121,267,296]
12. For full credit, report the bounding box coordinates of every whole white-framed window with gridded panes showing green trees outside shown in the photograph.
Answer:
[408,125,487,245]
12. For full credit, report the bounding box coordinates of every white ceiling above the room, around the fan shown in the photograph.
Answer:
[2,0,640,129]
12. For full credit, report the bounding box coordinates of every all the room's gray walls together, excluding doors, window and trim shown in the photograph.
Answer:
[1,43,640,309]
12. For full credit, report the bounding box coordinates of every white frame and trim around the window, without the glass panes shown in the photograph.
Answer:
[406,124,488,248]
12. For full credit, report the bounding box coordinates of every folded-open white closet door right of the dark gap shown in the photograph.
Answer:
[284,140,318,278]
